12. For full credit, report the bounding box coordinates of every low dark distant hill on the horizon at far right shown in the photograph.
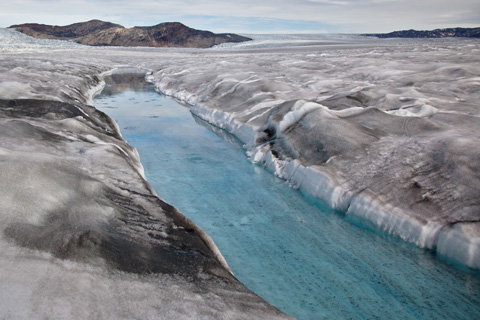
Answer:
[366,28,480,38]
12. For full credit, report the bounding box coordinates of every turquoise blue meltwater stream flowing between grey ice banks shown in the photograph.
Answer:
[95,78,480,319]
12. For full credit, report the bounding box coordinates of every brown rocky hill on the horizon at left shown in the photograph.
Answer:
[10,20,252,48]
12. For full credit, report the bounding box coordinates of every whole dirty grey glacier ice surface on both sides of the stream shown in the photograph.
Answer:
[0,29,480,319]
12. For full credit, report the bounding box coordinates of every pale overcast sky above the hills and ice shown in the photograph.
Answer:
[0,0,480,33]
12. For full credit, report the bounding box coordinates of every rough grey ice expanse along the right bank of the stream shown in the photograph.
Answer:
[150,39,480,268]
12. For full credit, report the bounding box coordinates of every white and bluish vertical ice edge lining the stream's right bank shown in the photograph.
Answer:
[150,72,480,270]
